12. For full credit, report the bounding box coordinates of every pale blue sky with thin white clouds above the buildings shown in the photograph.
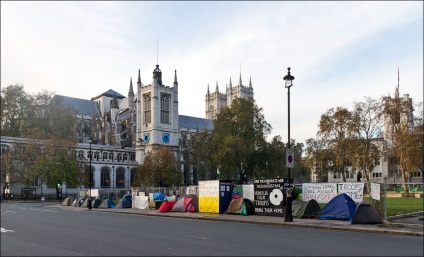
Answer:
[1,1,424,143]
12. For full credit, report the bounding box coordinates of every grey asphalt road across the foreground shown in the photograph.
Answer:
[1,203,423,256]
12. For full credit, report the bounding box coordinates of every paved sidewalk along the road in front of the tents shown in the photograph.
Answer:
[54,205,424,237]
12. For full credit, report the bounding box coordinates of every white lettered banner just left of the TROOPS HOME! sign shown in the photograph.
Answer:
[302,183,337,203]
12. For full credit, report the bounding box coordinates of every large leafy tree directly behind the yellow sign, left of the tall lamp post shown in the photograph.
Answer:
[212,98,271,184]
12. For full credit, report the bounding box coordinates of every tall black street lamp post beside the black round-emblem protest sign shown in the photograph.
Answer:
[283,67,294,222]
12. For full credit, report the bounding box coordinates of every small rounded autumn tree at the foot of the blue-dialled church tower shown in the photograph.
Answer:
[133,146,182,187]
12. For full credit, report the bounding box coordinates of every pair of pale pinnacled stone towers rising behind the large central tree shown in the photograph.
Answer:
[205,73,253,120]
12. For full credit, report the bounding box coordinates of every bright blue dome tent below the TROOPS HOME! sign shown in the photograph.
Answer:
[318,194,356,220]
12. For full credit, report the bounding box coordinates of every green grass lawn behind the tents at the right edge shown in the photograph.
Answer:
[319,197,424,217]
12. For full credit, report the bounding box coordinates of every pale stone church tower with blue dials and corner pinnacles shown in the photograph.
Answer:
[136,65,179,163]
